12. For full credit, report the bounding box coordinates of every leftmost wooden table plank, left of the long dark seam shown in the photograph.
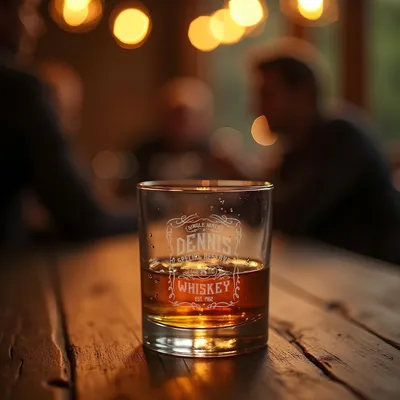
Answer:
[0,254,70,400]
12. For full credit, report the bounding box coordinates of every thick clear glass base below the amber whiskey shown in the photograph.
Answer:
[143,316,268,357]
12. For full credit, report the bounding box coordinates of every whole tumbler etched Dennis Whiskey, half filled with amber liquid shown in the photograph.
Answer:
[138,180,273,357]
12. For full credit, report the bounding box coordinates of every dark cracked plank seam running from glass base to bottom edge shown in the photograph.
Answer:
[270,317,369,400]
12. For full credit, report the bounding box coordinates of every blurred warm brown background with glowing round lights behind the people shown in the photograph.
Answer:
[35,0,400,206]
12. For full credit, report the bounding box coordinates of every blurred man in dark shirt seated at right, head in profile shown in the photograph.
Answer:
[253,39,400,264]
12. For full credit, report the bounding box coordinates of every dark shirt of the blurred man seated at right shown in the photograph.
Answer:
[273,111,400,264]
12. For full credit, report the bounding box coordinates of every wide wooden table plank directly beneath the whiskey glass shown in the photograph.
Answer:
[55,239,357,400]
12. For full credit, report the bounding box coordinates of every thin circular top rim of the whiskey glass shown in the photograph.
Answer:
[137,179,274,193]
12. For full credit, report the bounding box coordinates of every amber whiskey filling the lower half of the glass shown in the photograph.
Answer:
[141,258,269,328]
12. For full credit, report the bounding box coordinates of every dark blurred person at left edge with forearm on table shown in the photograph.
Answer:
[0,0,136,245]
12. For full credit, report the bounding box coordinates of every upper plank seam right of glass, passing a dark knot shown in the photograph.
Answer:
[272,273,400,350]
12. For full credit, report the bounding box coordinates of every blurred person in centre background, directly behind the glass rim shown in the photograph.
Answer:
[121,77,239,194]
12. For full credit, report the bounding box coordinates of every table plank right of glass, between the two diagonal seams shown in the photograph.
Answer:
[270,286,400,400]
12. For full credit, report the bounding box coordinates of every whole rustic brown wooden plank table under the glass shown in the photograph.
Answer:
[0,237,400,400]
